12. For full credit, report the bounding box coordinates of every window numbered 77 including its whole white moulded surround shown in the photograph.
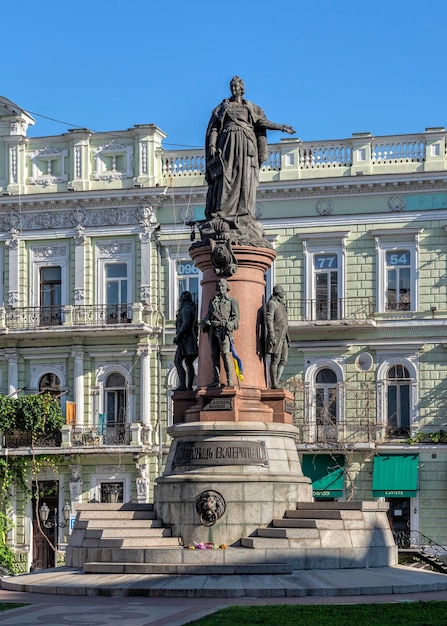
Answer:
[301,231,348,320]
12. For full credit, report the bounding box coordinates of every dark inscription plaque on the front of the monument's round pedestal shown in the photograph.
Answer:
[172,441,268,467]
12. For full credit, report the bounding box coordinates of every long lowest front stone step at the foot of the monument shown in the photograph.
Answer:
[84,562,292,575]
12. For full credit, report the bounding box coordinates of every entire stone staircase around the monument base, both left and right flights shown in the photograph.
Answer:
[66,502,397,575]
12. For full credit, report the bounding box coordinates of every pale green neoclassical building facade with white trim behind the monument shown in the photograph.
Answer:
[0,98,447,571]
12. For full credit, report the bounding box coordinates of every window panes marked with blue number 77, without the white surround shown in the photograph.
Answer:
[314,253,340,320]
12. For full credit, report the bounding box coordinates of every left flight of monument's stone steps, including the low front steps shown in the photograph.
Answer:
[65,503,292,575]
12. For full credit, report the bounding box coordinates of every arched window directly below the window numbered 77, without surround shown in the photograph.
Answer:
[315,367,338,442]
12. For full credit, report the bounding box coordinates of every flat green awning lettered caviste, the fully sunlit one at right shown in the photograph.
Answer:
[373,454,418,498]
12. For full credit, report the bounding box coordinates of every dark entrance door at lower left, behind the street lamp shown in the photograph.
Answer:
[32,480,59,571]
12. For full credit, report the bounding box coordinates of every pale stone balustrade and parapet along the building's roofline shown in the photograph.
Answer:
[0,125,447,195]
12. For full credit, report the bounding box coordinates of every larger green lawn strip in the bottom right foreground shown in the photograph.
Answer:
[188,600,447,626]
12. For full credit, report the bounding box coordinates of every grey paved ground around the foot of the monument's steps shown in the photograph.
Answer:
[0,568,447,626]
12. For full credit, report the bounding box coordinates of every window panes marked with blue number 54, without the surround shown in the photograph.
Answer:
[386,250,411,311]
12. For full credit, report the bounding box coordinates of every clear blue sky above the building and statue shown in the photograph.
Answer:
[0,0,447,148]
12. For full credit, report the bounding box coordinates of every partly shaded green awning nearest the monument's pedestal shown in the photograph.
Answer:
[302,454,345,500]
